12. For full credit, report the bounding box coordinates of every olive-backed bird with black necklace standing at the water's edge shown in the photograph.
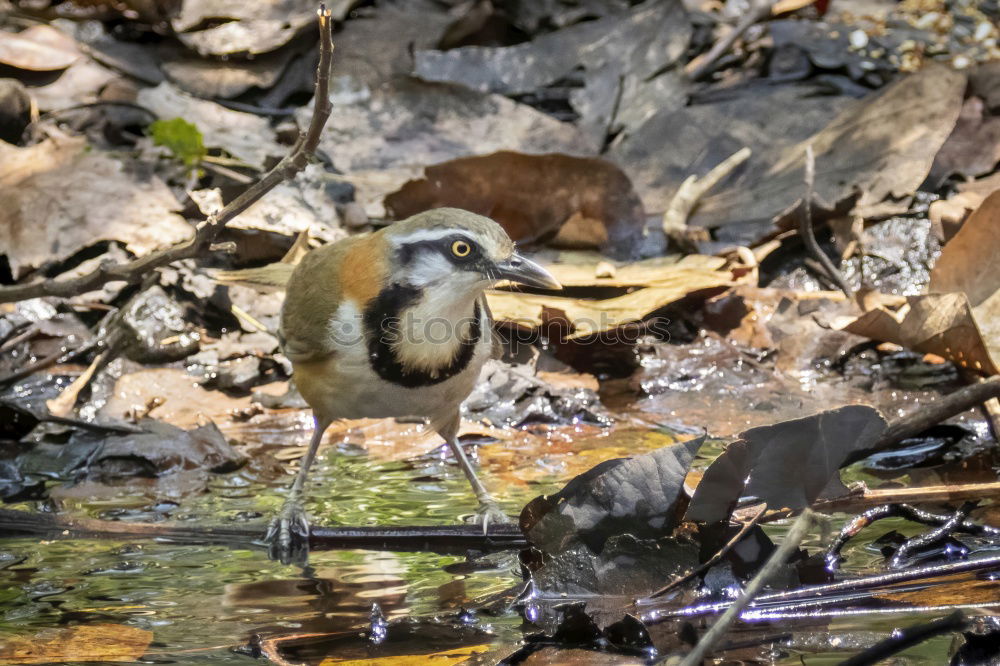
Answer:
[265,208,561,563]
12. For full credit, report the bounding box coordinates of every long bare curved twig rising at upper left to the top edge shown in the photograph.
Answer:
[0,5,333,303]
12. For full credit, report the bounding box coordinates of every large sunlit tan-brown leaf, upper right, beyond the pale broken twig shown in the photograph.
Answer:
[664,66,965,239]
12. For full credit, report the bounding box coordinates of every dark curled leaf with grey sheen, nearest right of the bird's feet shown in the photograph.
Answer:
[521,437,704,554]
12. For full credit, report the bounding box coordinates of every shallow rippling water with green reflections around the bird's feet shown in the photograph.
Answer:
[0,396,1000,665]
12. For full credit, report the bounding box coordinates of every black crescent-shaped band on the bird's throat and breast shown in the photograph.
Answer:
[364,284,483,388]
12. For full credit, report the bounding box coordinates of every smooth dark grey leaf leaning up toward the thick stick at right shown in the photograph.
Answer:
[684,405,886,523]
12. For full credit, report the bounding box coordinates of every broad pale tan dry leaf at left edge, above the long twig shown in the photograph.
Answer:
[0,138,192,278]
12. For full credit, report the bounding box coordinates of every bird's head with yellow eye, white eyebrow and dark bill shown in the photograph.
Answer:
[384,208,562,295]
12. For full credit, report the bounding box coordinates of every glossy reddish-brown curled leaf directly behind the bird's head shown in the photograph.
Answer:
[385,151,645,256]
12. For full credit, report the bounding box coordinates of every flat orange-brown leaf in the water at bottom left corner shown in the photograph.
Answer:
[0,624,153,666]
